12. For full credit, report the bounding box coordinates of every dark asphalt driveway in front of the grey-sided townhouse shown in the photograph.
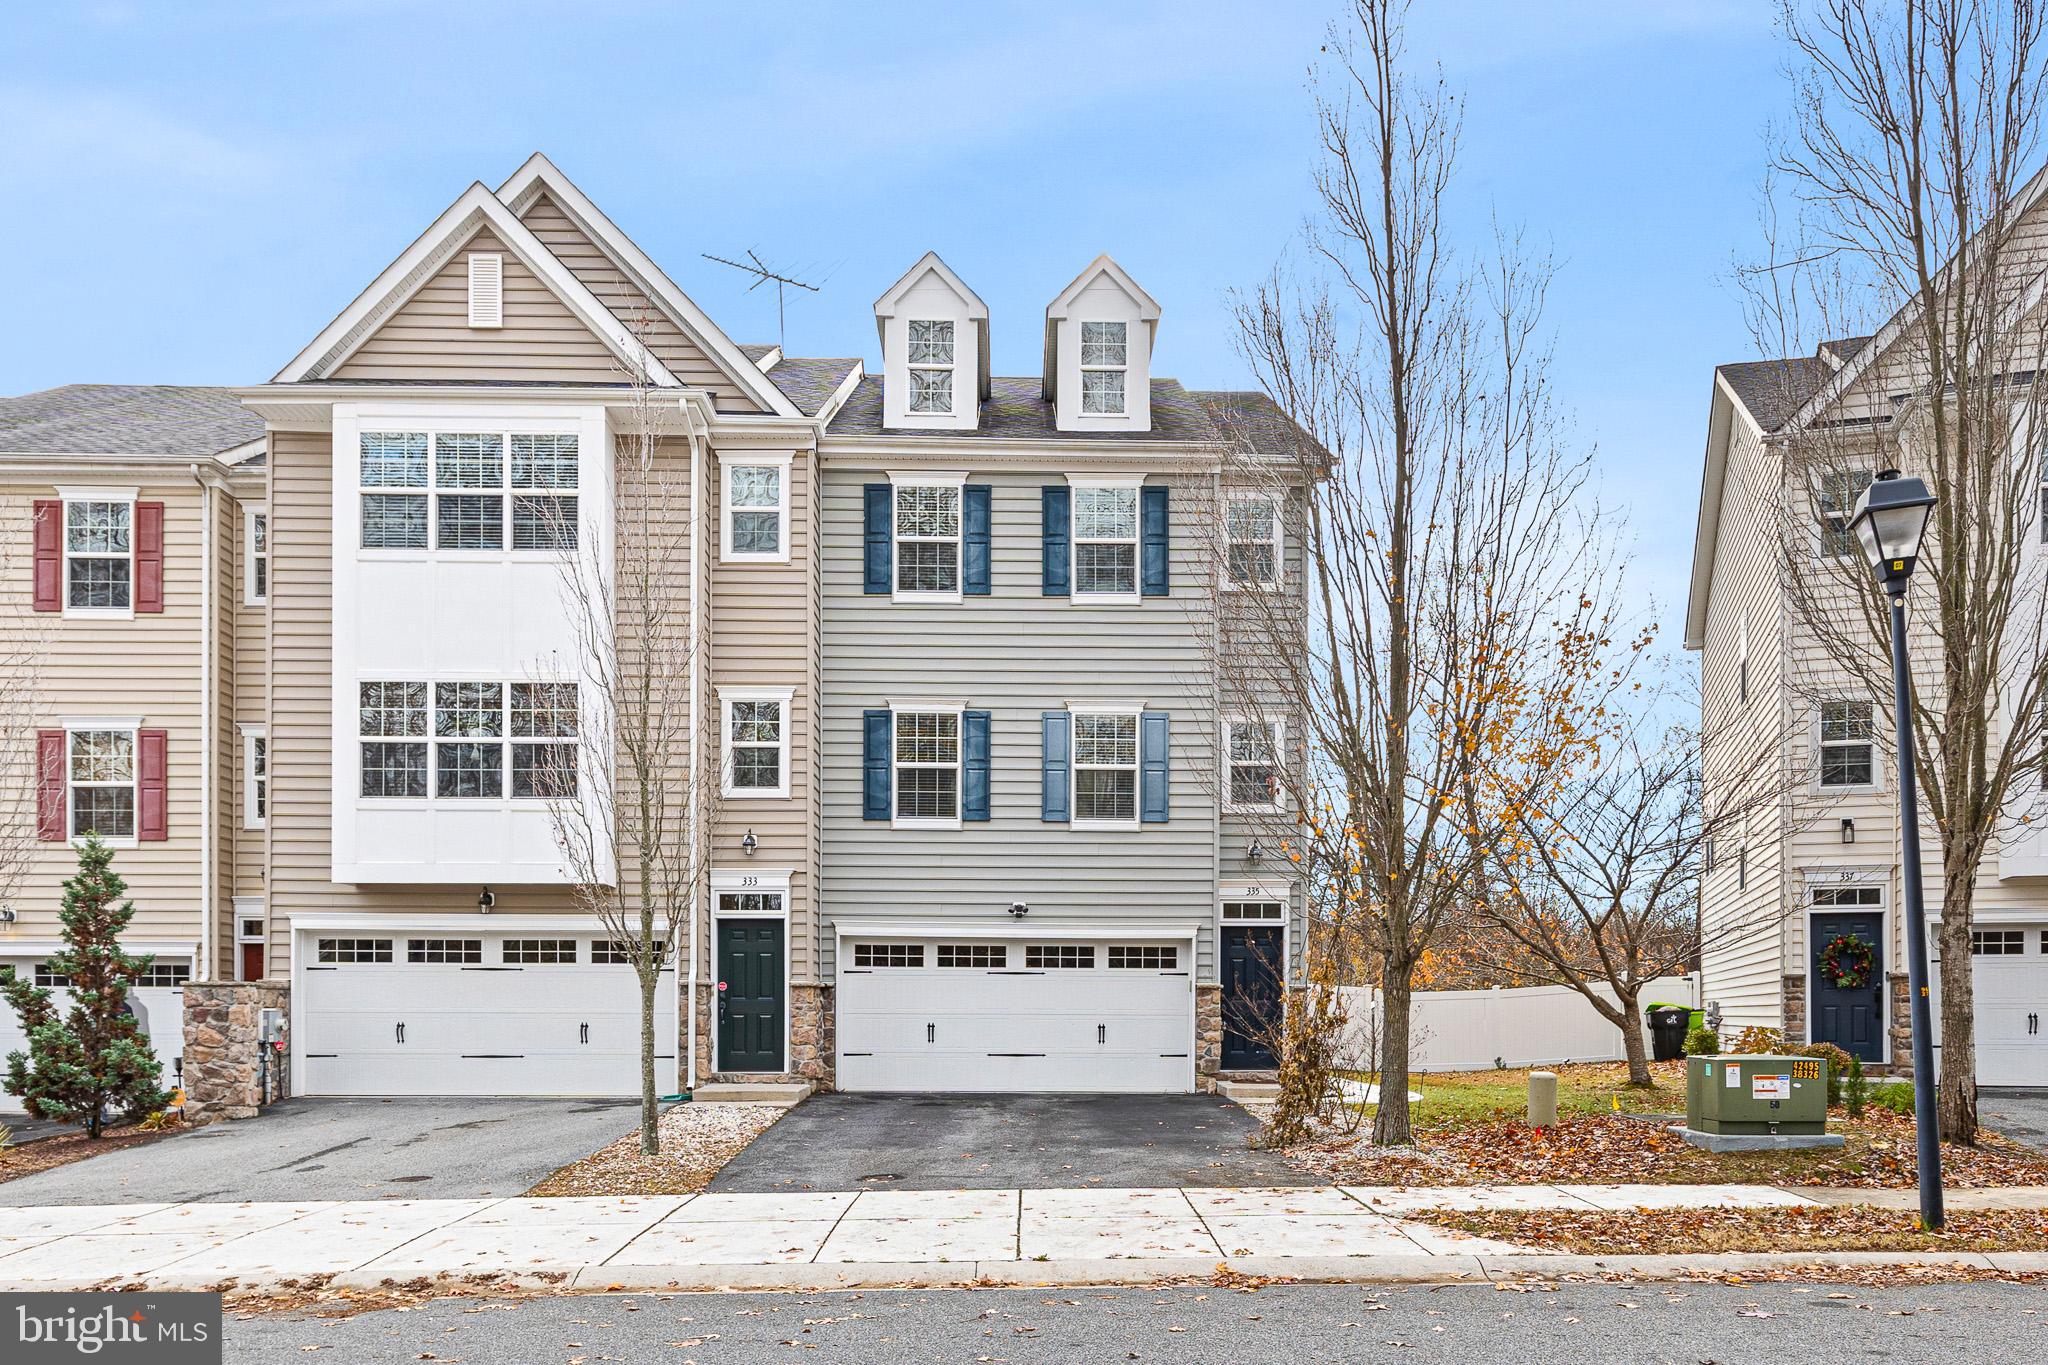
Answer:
[711,1093,1315,1193]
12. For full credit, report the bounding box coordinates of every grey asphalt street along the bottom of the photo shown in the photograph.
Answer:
[227,1283,2048,1365]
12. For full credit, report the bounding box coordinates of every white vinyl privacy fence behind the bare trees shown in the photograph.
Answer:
[1343,976,1700,1070]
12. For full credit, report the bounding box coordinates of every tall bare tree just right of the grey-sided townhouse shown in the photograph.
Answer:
[1219,0,1610,1144]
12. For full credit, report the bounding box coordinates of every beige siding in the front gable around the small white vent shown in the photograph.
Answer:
[334,227,627,385]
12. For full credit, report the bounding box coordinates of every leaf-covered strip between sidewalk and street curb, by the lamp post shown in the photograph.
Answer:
[1405,1205,2048,1257]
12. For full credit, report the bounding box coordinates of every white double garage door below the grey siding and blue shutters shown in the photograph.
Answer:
[838,939,1194,1095]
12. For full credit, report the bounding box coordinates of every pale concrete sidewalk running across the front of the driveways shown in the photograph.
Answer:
[0,1185,2048,1289]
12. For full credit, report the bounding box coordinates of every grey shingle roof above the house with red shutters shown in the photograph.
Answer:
[0,385,262,458]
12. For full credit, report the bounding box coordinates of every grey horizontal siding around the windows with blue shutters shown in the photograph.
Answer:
[819,465,1219,980]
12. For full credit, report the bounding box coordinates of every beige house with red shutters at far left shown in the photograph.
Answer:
[0,385,268,1107]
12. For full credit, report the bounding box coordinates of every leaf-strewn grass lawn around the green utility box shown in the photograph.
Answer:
[1286,1062,2048,1189]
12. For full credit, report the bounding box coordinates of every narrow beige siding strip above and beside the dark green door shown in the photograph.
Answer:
[700,450,819,986]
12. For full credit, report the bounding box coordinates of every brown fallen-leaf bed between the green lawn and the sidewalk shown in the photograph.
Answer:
[1286,1109,2048,1189]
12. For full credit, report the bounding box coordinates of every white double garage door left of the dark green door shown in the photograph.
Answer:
[291,931,676,1095]
